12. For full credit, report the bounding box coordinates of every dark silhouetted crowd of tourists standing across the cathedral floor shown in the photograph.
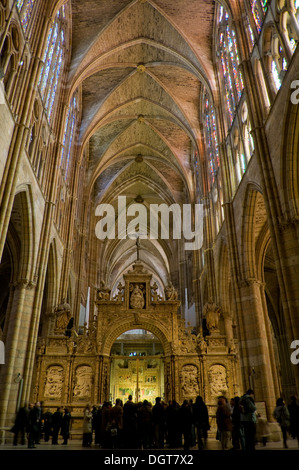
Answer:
[12,390,299,451]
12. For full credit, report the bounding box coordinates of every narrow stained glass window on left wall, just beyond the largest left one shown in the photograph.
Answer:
[60,93,79,179]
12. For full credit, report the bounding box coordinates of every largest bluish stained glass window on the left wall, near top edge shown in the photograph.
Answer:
[39,5,66,121]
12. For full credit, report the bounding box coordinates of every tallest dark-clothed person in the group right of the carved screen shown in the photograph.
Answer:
[239,389,256,451]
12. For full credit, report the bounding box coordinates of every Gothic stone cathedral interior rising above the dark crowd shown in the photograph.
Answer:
[0,0,299,442]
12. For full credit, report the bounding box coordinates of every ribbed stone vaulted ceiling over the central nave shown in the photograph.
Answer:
[69,0,219,288]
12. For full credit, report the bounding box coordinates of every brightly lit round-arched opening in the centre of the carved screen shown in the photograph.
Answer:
[110,329,164,403]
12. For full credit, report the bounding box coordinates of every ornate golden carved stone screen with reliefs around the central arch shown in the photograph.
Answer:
[33,261,240,429]
